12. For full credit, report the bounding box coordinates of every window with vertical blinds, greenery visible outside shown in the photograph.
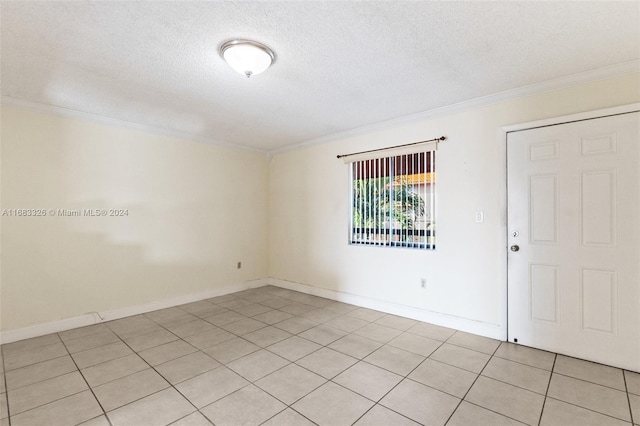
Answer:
[349,151,436,250]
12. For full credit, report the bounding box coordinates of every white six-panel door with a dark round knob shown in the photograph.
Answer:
[507,112,640,371]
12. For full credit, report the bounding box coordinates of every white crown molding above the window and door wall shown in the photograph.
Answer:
[269,60,640,157]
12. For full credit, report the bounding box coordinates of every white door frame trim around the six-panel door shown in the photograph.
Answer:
[500,102,640,342]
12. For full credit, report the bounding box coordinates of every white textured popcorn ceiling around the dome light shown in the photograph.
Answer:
[0,1,640,150]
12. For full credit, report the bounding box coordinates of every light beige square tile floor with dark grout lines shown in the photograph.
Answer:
[0,287,640,426]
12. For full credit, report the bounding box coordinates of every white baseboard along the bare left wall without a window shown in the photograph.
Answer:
[0,279,269,344]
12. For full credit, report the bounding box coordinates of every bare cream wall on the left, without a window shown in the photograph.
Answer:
[0,107,268,330]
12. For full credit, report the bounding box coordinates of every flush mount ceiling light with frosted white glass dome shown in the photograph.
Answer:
[220,40,276,78]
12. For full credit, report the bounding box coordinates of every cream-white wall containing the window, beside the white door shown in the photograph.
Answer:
[269,74,640,338]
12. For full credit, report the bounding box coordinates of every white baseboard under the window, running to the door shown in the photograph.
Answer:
[268,278,507,341]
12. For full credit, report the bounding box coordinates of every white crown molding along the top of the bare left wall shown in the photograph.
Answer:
[0,96,268,154]
